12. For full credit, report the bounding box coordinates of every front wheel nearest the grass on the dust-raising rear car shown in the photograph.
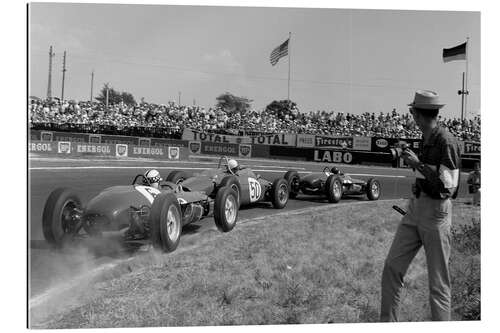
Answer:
[214,187,239,232]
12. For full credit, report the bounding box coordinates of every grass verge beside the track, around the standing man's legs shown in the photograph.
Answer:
[32,200,480,328]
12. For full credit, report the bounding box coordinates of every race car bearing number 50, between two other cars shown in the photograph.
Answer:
[166,156,288,209]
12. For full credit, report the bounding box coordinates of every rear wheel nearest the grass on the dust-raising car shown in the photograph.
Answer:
[151,192,182,252]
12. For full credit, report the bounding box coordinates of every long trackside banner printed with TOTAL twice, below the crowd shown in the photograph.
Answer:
[182,129,296,146]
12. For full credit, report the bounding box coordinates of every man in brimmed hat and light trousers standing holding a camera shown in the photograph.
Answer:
[380,90,460,321]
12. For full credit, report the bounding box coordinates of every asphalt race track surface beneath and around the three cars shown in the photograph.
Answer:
[28,156,467,296]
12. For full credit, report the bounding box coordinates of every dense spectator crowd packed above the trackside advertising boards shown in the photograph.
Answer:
[29,99,481,141]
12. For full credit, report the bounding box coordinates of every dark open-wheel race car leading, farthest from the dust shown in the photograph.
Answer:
[284,167,380,203]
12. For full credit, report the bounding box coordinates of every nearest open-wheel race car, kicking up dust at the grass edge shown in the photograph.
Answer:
[42,175,238,252]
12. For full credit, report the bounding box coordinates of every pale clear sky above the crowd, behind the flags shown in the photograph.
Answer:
[29,3,481,118]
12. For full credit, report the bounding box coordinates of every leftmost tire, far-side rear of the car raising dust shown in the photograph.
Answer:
[42,188,82,247]
